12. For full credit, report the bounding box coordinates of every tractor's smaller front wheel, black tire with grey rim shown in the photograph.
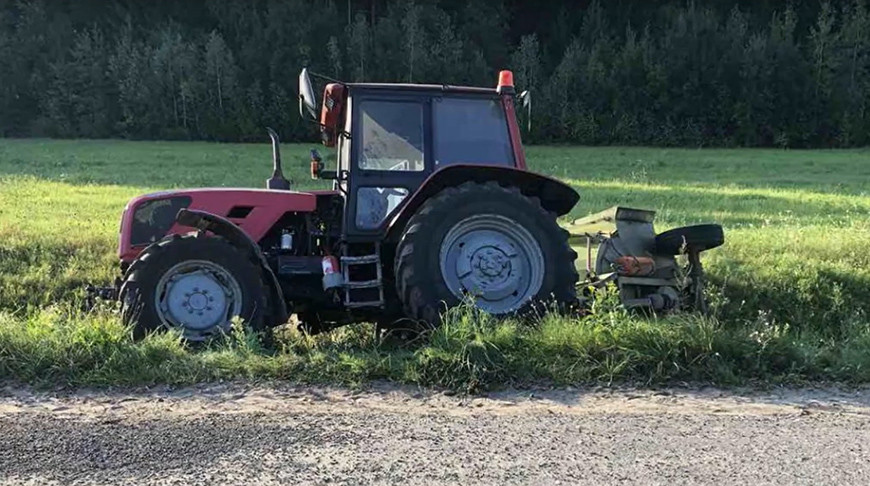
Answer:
[119,235,268,342]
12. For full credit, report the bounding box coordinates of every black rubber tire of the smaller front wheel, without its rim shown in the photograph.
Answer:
[119,234,268,341]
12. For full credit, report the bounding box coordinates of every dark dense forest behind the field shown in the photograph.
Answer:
[0,0,870,147]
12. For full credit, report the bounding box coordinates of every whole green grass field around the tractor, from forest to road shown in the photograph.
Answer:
[0,139,870,389]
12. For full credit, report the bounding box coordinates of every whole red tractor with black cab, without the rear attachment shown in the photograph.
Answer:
[116,70,579,341]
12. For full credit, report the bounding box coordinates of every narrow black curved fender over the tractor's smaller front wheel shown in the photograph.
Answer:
[175,209,290,324]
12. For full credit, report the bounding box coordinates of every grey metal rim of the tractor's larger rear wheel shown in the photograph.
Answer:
[439,214,544,314]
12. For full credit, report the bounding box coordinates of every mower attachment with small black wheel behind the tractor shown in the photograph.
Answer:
[566,206,724,312]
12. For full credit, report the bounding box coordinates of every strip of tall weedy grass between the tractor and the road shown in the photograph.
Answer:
[0,292,870,392]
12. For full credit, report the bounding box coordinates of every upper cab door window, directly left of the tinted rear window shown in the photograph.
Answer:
[359,100,424,172]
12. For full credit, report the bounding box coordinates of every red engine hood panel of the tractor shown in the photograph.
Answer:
[118,188,326,262]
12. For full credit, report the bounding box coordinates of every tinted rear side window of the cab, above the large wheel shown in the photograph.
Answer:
[432,97,514,166]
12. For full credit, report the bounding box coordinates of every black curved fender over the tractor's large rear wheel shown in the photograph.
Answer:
[386,164,580,241]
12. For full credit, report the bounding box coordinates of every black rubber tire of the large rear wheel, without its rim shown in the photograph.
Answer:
[394,182,579,325]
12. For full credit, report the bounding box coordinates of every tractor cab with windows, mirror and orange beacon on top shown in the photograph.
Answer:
[299,69,525,240]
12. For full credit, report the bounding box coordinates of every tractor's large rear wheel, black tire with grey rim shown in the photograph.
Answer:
[395,182,578,325]
